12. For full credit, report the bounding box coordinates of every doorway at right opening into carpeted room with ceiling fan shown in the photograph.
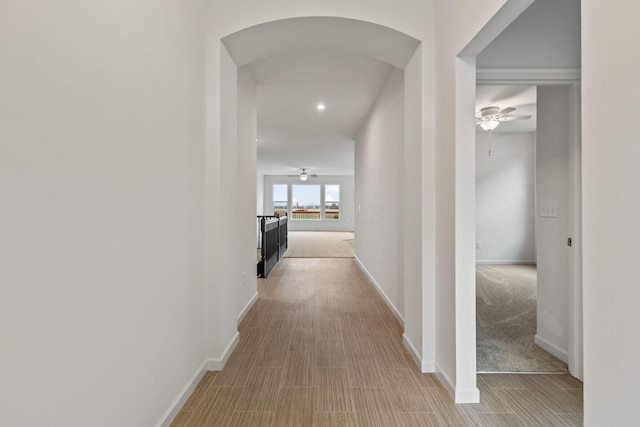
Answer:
[476,85,572,372]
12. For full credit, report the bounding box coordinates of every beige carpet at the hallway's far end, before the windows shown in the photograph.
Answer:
[284,231,354,258]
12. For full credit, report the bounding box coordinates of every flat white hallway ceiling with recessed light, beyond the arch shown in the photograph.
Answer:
[249,51,393,175]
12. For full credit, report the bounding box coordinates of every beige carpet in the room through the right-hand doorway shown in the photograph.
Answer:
[476,265,567,372]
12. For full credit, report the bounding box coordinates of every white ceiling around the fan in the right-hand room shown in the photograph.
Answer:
[476,85,537,133]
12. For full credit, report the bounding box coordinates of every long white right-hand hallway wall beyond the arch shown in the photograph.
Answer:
[355,68,404,322]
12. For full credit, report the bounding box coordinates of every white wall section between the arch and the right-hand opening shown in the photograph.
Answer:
[433,0,522,402]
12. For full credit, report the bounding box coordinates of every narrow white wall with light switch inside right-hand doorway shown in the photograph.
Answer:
[536,86,572,362]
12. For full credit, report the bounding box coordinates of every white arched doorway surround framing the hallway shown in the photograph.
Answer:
[207,17,435,392]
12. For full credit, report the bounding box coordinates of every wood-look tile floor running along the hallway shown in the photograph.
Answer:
[172,258,583,427]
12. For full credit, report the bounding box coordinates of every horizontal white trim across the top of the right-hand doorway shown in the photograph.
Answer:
[476,68,581,85]
